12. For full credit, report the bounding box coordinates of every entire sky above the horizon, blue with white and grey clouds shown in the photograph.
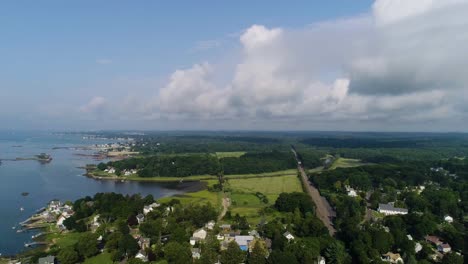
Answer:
[0,0,468,132]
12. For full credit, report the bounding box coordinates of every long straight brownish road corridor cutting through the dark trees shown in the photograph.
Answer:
[292,148,336,236]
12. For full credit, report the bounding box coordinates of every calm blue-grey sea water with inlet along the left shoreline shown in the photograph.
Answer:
[0,132,183,256]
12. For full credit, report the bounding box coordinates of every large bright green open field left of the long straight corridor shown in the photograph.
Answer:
[226,174,302,224]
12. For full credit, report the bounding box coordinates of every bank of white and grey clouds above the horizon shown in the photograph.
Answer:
[77,0,468,130]
